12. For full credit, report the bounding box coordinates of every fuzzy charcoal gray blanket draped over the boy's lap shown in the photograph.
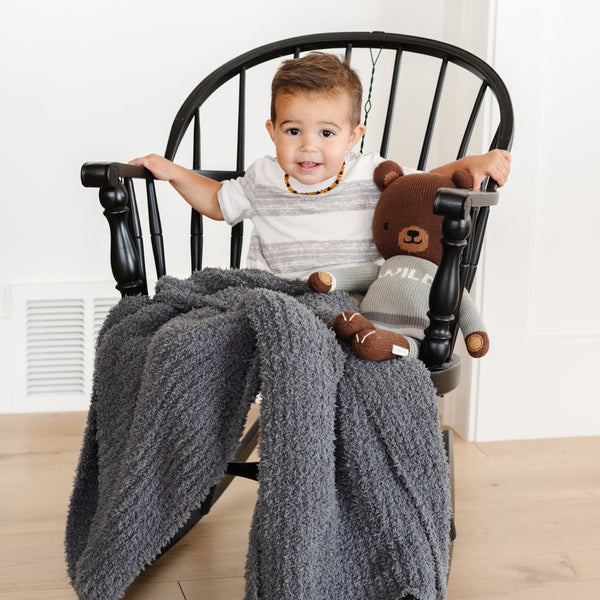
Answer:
[66,269,450,600]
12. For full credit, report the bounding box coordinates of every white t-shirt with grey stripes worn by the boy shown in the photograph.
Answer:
[219,152,414,278]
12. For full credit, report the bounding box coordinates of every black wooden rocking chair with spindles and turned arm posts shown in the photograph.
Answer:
[81,32,513,568]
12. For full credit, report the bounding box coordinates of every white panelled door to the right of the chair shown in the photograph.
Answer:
[467,0,600,440]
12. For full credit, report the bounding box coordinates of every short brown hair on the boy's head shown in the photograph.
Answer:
[271,52,362,127]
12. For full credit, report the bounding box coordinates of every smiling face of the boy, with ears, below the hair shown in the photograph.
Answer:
[267,93,365,185]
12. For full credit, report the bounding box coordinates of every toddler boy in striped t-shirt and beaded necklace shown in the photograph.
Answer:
[131,52,510,291]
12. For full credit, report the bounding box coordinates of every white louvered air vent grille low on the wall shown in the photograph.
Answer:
[0,281,119,412]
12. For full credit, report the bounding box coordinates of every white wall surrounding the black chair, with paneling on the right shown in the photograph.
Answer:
[0,0,600,439]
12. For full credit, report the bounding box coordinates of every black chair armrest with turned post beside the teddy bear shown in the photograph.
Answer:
[419,188,499,371]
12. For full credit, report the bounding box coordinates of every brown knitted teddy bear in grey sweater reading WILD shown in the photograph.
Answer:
[308,161,489,361]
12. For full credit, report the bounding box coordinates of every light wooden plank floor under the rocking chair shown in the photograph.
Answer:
[0,413,600,600]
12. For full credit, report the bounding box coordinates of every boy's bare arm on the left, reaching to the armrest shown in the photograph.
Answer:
[130,154,223,221]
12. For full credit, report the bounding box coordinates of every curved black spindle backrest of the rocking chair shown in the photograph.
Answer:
[132,32,513,289]
